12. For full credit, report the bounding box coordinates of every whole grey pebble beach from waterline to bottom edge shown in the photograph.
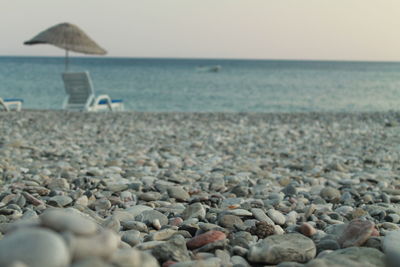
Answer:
[0,111,400,267]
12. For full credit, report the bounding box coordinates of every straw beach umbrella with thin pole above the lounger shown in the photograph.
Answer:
[24,23,107,70]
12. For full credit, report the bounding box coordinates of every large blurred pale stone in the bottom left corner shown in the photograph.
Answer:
[0,228,70,267]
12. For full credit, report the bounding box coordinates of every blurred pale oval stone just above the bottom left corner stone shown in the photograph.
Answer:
[40,209,97,235]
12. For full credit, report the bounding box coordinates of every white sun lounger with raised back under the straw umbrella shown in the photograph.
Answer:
[62,71,124,111]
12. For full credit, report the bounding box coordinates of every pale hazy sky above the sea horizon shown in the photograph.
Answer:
[0,0,400,61]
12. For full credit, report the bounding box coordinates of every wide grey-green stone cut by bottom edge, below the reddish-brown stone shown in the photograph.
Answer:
[306,247,386,267]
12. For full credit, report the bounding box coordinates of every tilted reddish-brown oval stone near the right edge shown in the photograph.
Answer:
[339,219,375,248]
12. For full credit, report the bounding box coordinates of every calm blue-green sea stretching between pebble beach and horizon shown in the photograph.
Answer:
[0,57,400,112]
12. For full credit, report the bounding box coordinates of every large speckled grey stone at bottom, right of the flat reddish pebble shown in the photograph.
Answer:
[247,233,316,264]
